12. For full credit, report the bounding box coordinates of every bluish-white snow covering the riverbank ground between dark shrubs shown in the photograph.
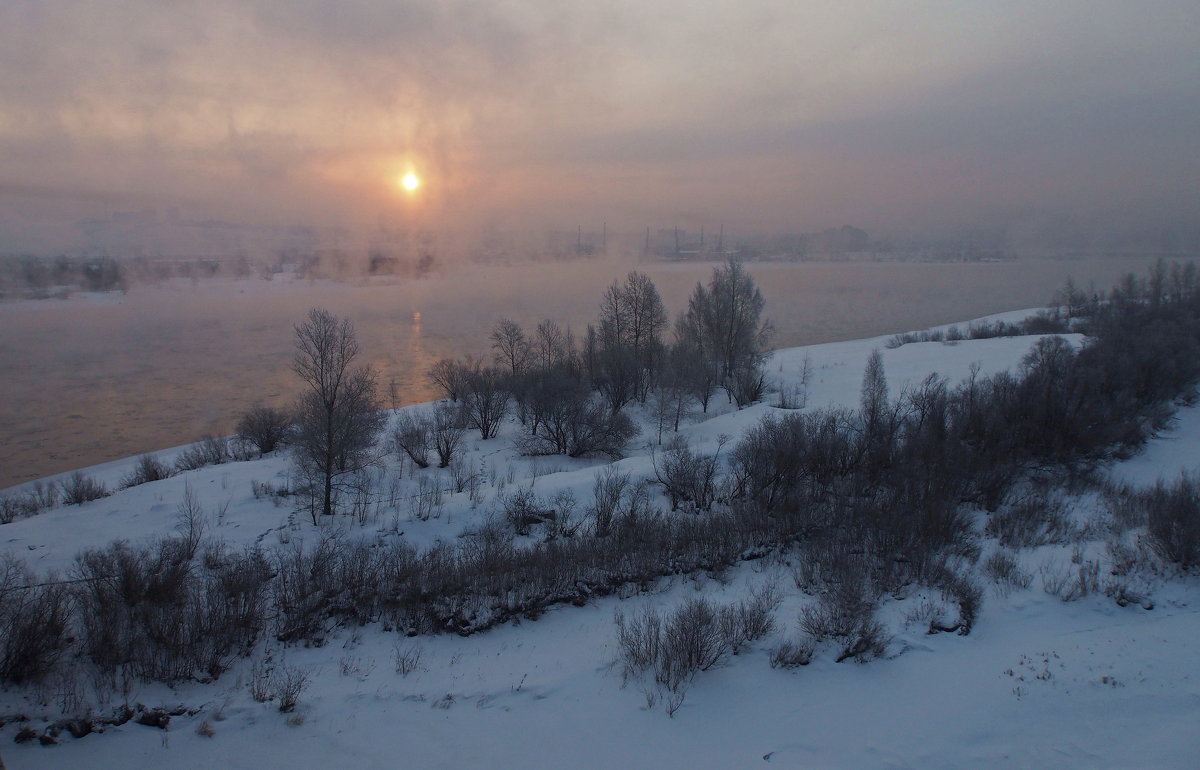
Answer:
[0,312,1200,770]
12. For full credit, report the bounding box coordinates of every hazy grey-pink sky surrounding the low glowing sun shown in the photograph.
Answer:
[0,0,1200,249]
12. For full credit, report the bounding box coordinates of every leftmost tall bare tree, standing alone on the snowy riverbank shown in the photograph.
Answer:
[293,308,386,523]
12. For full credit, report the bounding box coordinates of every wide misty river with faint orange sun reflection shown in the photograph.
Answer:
[0,257,1161,488]
